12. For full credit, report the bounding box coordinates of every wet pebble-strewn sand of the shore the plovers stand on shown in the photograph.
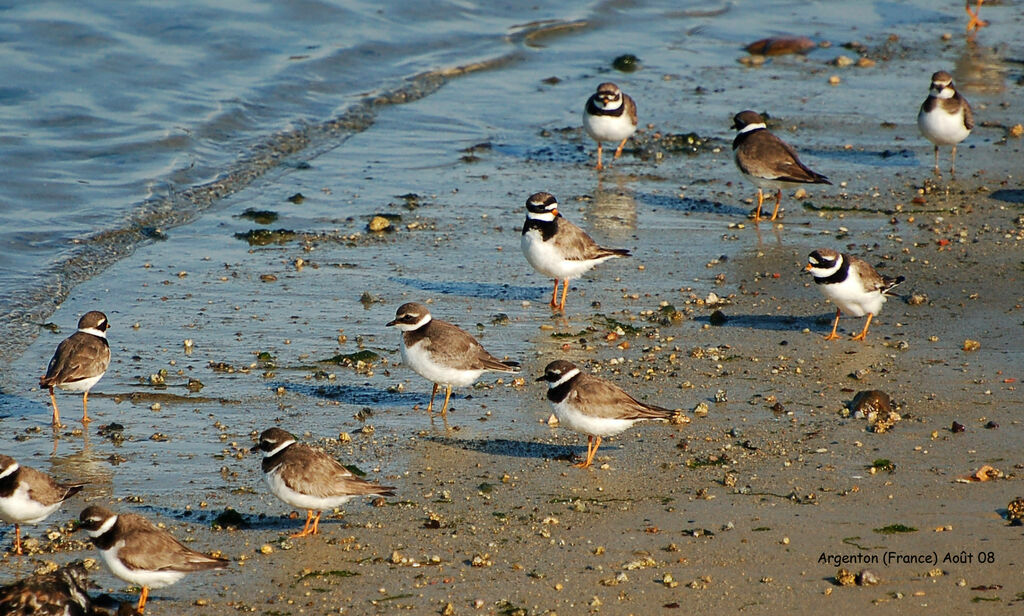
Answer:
[0,2,1024,615]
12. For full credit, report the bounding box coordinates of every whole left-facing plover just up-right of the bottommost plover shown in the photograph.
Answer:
[251,428,394,537]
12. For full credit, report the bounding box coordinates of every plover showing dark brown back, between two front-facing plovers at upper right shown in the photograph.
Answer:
[732,111,831,222]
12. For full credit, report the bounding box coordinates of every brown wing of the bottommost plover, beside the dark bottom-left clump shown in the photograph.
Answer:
[118,507,227,572]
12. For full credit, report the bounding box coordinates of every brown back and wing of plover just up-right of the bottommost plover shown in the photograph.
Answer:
[281,443,394,498]
